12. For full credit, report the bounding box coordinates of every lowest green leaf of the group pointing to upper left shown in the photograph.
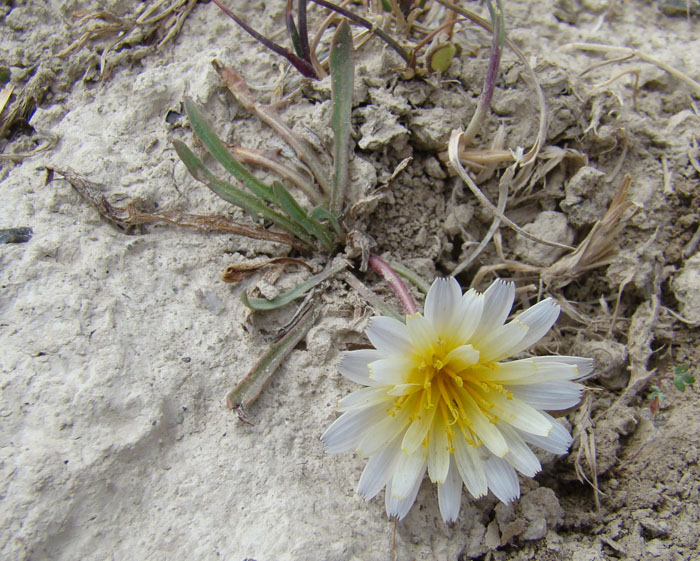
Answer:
[173,140,314,247]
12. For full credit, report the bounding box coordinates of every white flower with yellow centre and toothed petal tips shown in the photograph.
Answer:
[321,278,593,522]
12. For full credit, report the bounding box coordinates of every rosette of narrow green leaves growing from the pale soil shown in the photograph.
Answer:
[173,20,425,420]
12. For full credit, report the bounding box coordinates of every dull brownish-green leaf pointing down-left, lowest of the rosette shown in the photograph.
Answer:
[226,307,319,409]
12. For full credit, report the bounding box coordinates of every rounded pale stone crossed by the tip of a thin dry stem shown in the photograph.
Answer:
[514,210,574,267]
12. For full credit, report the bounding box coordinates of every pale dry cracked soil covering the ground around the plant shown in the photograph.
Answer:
[0,0,700,561]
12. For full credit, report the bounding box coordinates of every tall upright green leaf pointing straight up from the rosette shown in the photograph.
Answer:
[330,20,354,216]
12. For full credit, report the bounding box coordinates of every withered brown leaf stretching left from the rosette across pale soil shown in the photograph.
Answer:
[48,168,306,251]
